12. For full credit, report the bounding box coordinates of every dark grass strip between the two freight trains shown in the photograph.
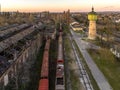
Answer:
[49,40,58,90]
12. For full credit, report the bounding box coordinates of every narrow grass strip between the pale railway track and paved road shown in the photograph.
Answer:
[73,41,100,90]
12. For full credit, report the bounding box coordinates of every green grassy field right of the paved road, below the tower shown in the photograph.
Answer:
[88,48,120,90]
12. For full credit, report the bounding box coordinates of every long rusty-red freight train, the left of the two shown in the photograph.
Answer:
[38,39,50,90]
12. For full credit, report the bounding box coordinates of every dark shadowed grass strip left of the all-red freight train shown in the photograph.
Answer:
[26,44,44,90]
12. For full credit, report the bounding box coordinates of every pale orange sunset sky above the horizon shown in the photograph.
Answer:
[0,0,120,12]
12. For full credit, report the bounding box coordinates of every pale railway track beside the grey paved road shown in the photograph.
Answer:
[70,37,94,90]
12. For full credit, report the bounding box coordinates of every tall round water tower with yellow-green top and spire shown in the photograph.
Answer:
[88,7,97,40]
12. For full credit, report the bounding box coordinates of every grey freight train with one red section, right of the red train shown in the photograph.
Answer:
[55,31,65,90]
